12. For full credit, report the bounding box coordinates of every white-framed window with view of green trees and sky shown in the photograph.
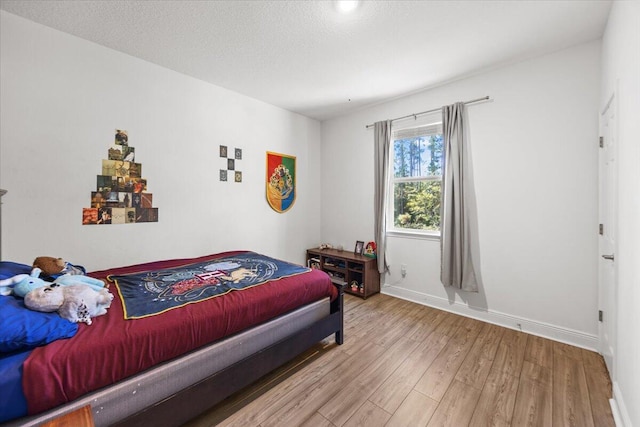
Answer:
[387,123,444,235]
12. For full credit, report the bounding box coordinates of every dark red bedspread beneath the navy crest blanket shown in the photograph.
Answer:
[22,252,337,414]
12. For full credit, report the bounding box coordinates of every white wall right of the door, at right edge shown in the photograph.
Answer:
[600,1,640,427]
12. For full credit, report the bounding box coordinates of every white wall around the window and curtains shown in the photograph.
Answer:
[322,41,601,348]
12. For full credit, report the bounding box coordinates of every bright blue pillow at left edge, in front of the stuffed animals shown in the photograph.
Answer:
[0,296,78,353]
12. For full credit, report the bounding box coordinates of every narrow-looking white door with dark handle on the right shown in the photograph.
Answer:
[598,93,618,378]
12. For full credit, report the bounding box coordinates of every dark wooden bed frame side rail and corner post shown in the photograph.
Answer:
[114,284,344,427]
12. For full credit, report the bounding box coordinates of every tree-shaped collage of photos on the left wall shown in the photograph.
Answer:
[82,129,158,225]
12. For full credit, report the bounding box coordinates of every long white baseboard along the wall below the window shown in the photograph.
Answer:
[381,285,598,352]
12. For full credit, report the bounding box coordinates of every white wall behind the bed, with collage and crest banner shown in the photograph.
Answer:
[0,11,320,270]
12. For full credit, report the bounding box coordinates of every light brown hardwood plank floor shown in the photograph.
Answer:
[186,295,614,427]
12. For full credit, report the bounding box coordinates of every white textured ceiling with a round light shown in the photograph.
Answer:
[0,0,611,120]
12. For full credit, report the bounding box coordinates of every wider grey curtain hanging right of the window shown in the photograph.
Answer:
[440,102,480,292]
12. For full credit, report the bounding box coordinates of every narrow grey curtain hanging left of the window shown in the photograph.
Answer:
[374,120,391,274]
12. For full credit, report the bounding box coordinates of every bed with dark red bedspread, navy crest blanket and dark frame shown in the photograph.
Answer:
[0,251,343,426]
